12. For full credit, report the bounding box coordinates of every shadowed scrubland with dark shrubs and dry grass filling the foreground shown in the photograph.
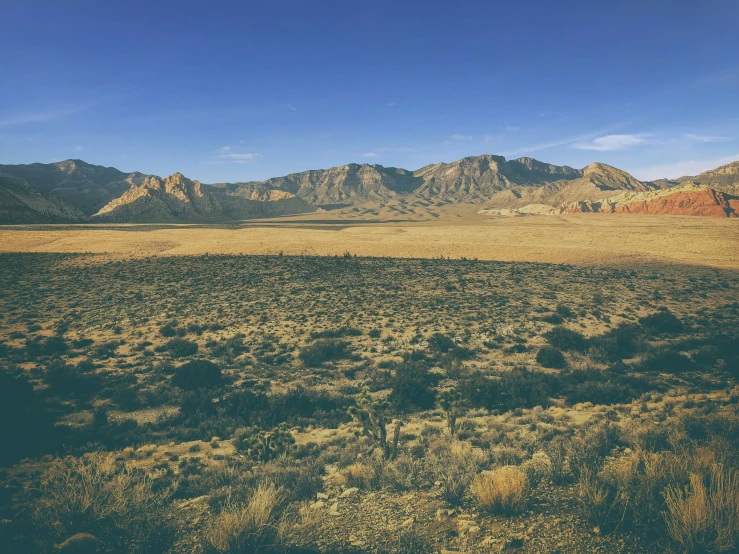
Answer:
[0,254,739,554]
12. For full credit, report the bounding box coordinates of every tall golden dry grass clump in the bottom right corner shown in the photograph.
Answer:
[665,465,739,554]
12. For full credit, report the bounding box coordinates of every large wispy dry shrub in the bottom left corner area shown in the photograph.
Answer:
[33,453,176,553]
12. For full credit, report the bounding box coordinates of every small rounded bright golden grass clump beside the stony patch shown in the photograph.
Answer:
[470,466,531,513]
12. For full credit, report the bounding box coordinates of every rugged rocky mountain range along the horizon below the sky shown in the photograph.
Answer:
[0,155,739,224]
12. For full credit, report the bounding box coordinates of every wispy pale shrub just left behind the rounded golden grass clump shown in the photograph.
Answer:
[426,441,484,506]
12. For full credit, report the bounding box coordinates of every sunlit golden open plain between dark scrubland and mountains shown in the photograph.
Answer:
[0,214,739,269]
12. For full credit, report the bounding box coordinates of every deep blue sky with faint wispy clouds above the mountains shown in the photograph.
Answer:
[0,0,739,183]
